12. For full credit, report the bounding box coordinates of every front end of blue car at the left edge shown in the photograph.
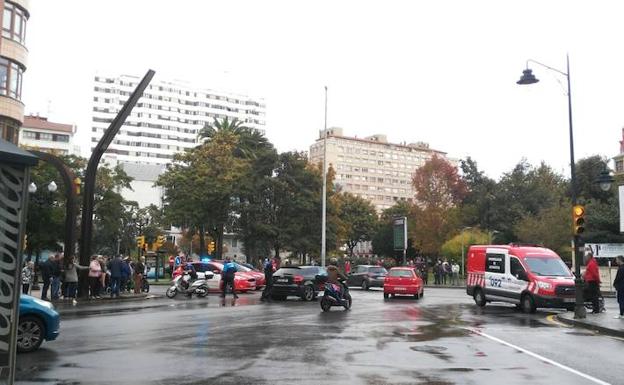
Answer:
[17,294,61,353]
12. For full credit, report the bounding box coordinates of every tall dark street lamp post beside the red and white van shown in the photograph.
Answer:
[516,55,587,319]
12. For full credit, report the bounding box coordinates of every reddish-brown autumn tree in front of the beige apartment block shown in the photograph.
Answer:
[410,155,468,256]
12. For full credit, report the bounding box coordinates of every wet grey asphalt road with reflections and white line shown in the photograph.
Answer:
[17,289,624,385]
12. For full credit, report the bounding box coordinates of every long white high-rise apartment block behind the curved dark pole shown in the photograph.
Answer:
[91,75,266,165]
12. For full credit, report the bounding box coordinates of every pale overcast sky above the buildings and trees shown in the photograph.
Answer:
[23,0,624,177]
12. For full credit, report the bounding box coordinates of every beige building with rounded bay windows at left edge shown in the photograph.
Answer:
[0,0,30,144]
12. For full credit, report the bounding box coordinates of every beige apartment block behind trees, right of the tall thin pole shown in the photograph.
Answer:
[310,127,454,211]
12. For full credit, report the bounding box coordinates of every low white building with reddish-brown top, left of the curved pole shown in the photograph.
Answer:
[19,115,80,155]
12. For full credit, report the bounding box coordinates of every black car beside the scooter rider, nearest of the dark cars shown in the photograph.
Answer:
[271,266,327,301]
